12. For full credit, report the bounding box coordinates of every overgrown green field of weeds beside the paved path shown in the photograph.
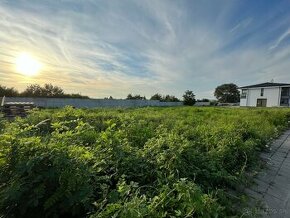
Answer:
[0,107,290,218]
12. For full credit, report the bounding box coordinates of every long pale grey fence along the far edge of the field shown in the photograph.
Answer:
[5,97,182,108]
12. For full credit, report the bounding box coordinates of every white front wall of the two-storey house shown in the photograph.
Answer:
[245,87,281,107]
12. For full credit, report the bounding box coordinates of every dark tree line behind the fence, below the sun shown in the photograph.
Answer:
[0,84,89,98]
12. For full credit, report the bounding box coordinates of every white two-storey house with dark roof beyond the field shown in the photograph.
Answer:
[240,82,290,107]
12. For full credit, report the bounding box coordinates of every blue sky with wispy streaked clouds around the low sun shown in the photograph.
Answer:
[0,0,290,99]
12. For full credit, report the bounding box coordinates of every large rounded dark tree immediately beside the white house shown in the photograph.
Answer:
[214,83,240,103]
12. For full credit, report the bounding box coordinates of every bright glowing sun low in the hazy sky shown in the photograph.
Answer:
[16,53,42,76]
